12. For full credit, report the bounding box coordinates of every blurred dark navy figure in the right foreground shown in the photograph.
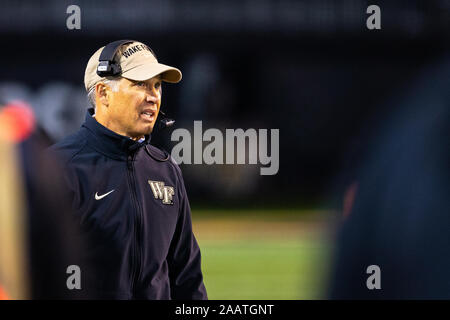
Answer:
[330,59,450,299]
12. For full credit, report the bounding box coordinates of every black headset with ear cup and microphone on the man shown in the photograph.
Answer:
[97,40,175,130]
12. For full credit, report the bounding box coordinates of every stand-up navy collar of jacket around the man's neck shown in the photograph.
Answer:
[83,108,151,159]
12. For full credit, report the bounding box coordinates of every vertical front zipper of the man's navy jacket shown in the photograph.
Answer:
[127,155,142,295]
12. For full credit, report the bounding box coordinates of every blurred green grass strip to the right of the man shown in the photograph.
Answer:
[193,211,329,299]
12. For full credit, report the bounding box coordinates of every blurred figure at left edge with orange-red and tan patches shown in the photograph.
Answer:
[0,101,87,299]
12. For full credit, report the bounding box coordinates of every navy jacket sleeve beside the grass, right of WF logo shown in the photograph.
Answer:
[167,166,208,300]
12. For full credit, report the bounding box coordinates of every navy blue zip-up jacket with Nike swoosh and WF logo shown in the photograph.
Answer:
[50,109,207,299]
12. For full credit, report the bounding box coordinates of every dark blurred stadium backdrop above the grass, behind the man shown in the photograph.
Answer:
[0,0,450,206]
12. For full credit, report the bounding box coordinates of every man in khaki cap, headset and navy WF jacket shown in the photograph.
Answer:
[51,41,207,299]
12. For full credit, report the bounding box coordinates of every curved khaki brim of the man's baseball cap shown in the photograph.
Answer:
[122,63,182,83]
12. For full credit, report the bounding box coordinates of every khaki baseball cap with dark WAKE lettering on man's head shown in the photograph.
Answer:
[84,41,182,91]
